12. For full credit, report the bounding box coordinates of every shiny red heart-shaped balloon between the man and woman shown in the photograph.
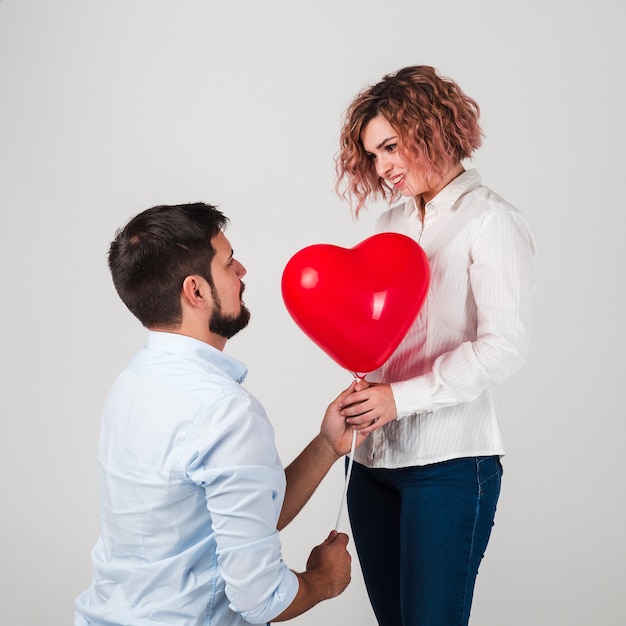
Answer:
[282,233,430,374]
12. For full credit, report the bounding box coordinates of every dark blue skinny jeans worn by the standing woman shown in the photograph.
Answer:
[348,456,502,626]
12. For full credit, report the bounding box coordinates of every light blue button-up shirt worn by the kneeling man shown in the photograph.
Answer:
[74,332,298,626]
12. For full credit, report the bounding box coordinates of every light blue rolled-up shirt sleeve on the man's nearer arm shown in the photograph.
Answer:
[187,393,298,624]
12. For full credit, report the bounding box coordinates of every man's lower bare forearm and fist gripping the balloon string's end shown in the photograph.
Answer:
[272,530,352,622]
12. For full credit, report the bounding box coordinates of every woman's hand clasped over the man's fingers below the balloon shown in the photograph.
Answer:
[339,381,398,434]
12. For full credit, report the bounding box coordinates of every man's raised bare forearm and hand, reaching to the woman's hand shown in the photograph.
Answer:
[277,381,367,530]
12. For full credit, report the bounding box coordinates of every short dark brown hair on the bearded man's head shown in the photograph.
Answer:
[108,202,228,327]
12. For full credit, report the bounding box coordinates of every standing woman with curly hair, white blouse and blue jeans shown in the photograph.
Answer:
[336,66,534,626]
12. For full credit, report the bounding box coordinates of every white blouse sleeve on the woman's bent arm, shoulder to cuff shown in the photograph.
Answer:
[391,210,535,418]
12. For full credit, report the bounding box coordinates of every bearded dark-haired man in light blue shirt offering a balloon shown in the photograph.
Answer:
[75,203,363,626]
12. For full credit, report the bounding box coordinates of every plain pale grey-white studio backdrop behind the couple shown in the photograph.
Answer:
[0,0,626,626]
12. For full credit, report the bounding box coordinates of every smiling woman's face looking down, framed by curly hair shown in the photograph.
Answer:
[361,115,437,202]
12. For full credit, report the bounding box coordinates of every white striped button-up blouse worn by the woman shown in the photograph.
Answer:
[355,170,535,468]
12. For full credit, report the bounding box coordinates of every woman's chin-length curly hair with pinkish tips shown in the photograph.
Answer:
[335,65,483,217]
